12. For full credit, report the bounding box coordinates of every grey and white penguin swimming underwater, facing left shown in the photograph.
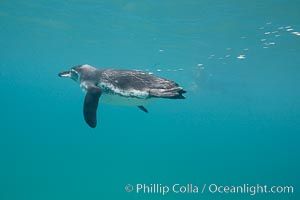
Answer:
[58,64,186,128]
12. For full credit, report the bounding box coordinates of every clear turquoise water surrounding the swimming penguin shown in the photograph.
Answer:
[0,0,300,200]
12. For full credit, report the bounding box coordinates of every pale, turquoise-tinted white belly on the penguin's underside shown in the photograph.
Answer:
[100,94,154,106]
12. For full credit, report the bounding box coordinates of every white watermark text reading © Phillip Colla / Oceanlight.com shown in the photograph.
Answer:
[125,183,294,196]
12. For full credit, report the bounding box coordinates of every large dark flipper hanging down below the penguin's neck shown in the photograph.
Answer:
[83,86,102,128]
